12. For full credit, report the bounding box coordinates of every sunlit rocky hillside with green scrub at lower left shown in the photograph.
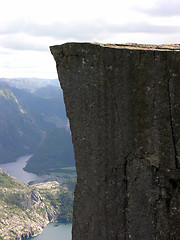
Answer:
[0,169,75,240]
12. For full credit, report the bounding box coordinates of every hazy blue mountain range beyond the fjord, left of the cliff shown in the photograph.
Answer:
[0,79,75,176]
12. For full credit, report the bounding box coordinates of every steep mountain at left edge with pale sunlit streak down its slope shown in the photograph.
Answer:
[0,82,43,163]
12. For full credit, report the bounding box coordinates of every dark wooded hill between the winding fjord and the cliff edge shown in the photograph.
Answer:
[24,128,75,177]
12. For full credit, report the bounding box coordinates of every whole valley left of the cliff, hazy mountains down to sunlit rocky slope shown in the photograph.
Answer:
[0,78,76,240]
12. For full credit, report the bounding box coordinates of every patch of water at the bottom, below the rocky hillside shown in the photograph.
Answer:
[29,223,72,240]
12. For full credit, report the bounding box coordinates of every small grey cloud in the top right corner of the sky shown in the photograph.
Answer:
[133,0,180,17]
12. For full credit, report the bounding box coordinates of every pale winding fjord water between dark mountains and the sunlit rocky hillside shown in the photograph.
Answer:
[0,155,41,184]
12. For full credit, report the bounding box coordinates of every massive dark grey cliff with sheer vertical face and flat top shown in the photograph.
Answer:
[51,43,180,240]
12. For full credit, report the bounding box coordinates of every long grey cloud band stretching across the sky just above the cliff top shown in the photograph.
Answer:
[0,19,180,40]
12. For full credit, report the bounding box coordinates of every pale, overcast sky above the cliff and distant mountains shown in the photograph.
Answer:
[0,0,180,79]
